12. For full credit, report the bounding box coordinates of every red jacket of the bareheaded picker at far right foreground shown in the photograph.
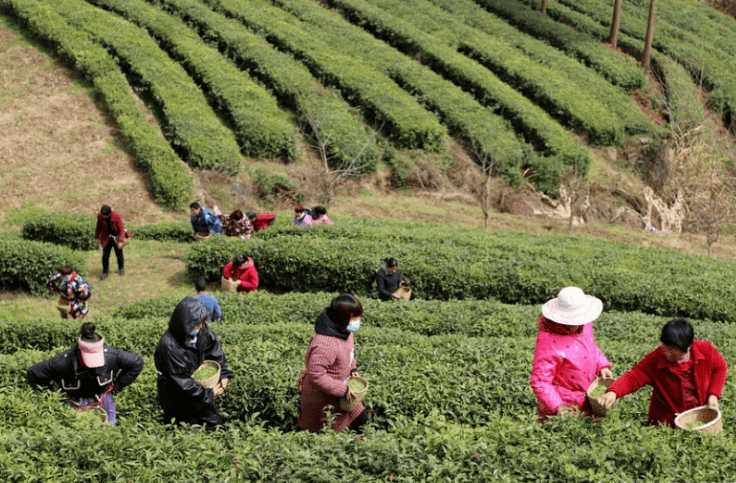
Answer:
[608,340,728,426]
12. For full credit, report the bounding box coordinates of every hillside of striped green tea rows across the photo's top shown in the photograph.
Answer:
[7,0,736,205]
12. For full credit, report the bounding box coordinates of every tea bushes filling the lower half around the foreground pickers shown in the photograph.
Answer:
[0,217,736,483]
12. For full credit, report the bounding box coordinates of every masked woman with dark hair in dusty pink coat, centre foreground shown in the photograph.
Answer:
[296,294,368,431]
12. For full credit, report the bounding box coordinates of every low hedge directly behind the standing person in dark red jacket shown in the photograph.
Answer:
[21,213,192,250]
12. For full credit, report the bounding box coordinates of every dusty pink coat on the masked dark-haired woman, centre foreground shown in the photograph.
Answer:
[297,311,363,431]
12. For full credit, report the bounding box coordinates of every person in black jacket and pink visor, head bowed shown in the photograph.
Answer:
[27,322,143,426]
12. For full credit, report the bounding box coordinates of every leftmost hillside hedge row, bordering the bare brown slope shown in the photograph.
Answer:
[0,0,192,207]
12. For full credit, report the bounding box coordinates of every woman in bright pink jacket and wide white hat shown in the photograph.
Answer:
[530,287,613,421]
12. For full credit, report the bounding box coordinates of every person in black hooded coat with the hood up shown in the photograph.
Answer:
[154,297,233,429]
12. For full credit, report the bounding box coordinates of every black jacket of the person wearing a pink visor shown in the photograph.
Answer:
[26,345,143,401]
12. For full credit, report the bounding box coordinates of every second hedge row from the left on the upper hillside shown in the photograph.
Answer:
[54,0,242,174]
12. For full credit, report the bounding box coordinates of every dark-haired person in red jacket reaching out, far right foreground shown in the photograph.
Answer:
[600,319,728,427]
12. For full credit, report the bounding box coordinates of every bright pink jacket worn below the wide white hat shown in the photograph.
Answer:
[529,317,611,419]
